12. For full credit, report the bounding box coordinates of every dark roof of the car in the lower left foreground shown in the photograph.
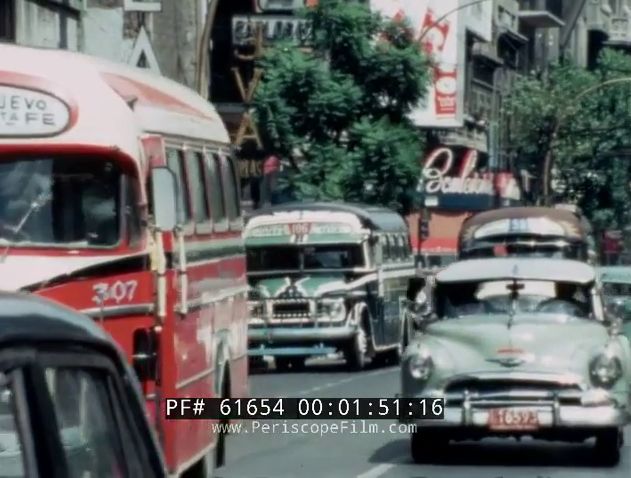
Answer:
[0,292,117,350]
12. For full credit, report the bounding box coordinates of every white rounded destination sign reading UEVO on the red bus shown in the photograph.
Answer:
[0,85,70,136]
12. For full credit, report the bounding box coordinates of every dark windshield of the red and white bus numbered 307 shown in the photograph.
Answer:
[0,157,121,248]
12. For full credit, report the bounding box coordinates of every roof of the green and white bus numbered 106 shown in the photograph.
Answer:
[248,201,408,232]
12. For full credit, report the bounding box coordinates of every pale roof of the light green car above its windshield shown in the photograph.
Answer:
[436,257,596,284]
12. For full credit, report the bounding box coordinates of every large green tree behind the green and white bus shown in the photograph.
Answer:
[254,0,428,213]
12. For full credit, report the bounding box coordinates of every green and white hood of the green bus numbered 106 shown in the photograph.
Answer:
[250,274,347,299]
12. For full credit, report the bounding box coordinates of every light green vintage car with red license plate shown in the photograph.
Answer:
[401,258,631,466]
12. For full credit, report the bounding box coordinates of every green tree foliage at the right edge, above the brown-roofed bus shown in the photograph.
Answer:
[504,49,631,229]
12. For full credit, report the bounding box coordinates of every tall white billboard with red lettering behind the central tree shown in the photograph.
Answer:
[370,0,464,128]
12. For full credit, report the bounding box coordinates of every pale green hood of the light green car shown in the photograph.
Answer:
[421,314,609,375]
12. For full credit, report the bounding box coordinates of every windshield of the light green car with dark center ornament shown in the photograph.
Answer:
[438,281,591,318]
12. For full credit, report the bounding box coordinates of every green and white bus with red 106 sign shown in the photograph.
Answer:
[244,202,421,370]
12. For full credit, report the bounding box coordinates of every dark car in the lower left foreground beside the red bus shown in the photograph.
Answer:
[0,292,166,478]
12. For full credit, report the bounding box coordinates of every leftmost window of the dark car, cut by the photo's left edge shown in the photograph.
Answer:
[0,378,26,478]
